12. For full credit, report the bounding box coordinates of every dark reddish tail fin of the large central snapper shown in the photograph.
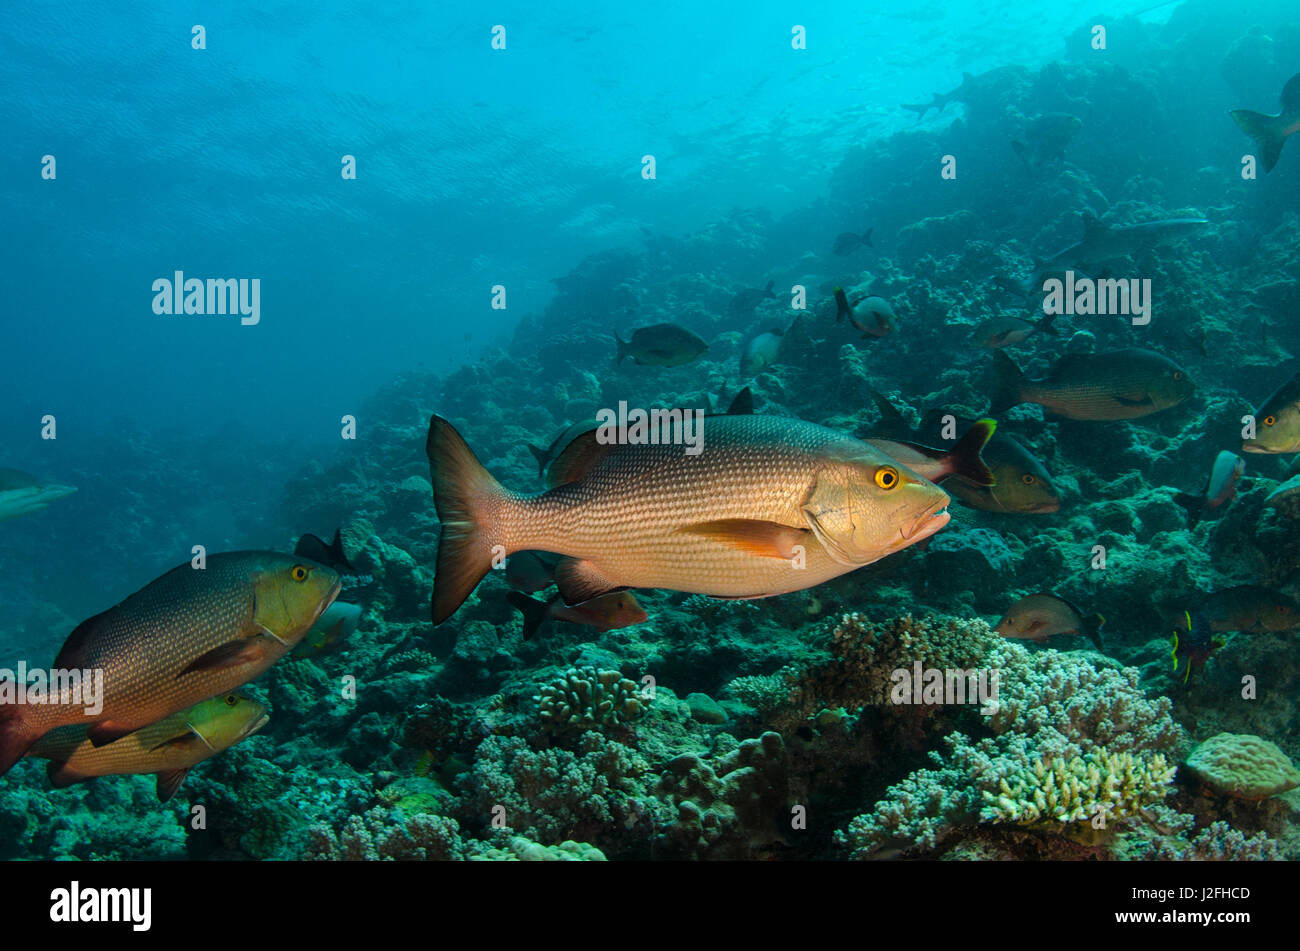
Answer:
[425,416,510,625]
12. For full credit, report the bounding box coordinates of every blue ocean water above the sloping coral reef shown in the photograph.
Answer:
[0,0,1297,867]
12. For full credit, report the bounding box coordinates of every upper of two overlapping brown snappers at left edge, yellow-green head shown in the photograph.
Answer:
[0,551,341,774]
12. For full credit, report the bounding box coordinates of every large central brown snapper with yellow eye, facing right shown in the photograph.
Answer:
[426,416,949,625]
